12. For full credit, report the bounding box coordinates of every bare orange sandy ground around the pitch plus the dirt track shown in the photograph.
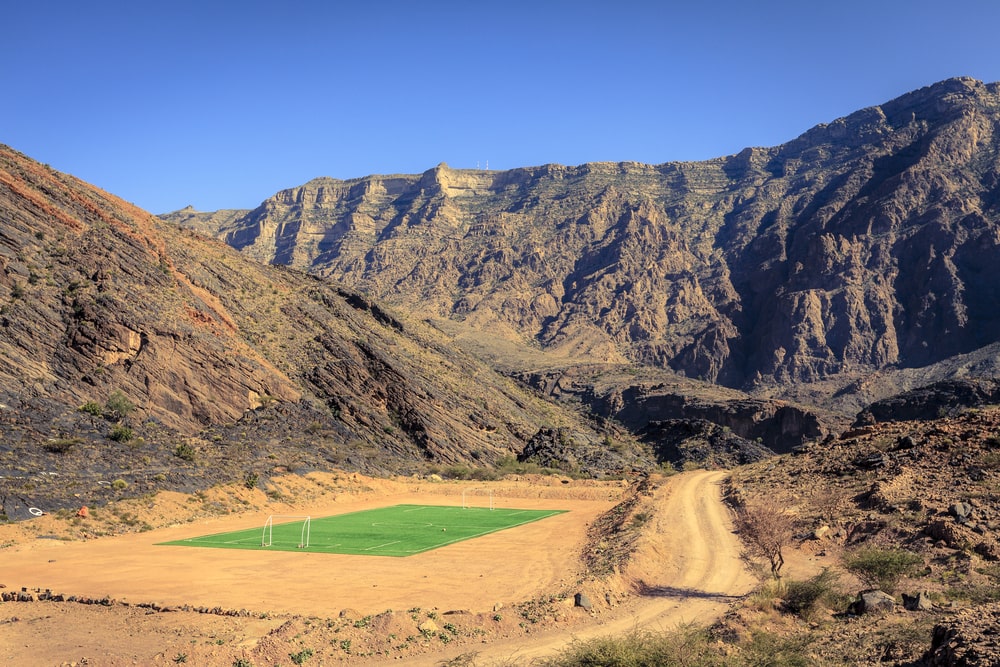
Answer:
[0,472,752,667]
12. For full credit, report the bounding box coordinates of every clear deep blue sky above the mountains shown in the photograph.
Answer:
[0,0,1000,213]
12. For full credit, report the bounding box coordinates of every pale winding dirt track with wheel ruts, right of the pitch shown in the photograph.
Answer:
[407,471,755,667]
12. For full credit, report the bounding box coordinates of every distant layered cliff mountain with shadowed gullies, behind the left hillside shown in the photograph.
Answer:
[189,79,1000,407]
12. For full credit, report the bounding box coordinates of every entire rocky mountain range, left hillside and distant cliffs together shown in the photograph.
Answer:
[0,79,1000,517]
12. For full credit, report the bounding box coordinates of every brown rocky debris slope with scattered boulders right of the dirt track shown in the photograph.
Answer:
[731,405,1000,665]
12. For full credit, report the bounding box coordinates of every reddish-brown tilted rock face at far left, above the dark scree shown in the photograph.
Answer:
[0,147,301,432]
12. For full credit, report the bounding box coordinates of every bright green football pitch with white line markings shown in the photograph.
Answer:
[154,505,566,556]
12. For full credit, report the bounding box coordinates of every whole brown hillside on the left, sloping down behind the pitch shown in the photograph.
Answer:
[0,147,635,517]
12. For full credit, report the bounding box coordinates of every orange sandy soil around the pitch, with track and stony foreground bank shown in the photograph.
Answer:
[0,473,751,667]
